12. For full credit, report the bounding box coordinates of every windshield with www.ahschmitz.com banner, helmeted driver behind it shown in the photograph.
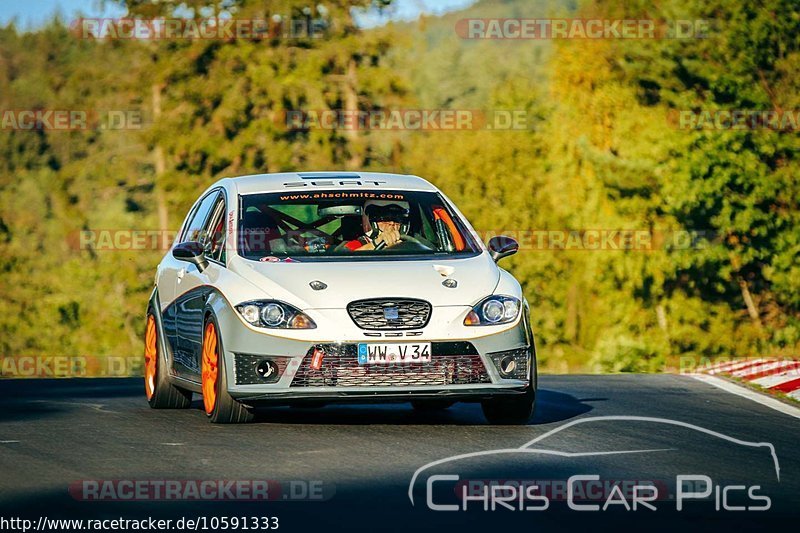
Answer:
[234,190,480,260]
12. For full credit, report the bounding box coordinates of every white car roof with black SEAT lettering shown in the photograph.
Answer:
[209,171,438,194]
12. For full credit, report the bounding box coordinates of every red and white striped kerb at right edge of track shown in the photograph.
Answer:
[691,357,800,418]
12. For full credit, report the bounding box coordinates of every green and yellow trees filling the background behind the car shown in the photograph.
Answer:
[0,0,800,372]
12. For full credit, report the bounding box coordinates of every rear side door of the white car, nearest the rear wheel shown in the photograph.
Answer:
[171,189,220,379]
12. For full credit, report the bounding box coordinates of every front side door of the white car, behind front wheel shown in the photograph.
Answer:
[173,192,226,380]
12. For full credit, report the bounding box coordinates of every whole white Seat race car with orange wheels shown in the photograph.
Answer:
[145,172,536,424]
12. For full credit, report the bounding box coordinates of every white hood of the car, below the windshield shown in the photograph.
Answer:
[230,253,500,309]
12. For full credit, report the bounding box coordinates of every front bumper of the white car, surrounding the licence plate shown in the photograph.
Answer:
[215,300,536,406]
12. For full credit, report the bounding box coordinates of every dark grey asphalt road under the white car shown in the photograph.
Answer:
[0,375,800,532]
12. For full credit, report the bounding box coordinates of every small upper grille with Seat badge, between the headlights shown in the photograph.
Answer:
[347,298,431,329]
